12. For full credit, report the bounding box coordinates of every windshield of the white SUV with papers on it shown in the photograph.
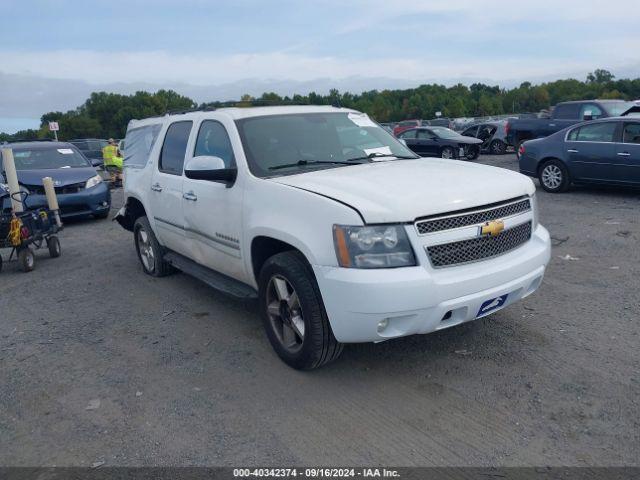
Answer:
[236,112,418,177]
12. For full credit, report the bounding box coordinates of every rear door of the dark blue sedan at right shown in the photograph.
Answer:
[565,121,624,182]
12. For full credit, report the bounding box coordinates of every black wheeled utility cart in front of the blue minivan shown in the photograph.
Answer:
[0,189,62,272]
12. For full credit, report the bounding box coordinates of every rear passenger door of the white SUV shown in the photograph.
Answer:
[148,121,193,255]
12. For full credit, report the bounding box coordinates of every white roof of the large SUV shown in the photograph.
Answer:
[129,105,360,127]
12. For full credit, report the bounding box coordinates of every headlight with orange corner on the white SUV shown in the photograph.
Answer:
[333,225,416,268]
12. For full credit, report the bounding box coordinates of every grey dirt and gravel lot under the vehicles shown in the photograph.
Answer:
[0,154,640,466]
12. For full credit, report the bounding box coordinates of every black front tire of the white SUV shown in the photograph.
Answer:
[258,251,343,370]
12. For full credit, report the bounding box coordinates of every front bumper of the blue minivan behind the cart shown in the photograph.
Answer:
[20,182,111,218]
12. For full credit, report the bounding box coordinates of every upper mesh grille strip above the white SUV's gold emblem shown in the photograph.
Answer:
[416,198,531,235]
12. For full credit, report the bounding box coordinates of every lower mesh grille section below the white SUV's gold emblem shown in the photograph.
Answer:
[426,222,531,267]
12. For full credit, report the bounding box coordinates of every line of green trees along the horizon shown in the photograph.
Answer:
[0,69,640,142]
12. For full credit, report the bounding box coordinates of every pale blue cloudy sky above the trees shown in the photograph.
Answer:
[0,0,640,132]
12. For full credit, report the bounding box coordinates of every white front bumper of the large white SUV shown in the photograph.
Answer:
[313,226,551,342]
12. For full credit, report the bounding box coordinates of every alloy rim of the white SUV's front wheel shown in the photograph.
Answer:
[266,275,304,353]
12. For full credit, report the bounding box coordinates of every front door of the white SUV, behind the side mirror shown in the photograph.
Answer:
[183,120,245,279]
